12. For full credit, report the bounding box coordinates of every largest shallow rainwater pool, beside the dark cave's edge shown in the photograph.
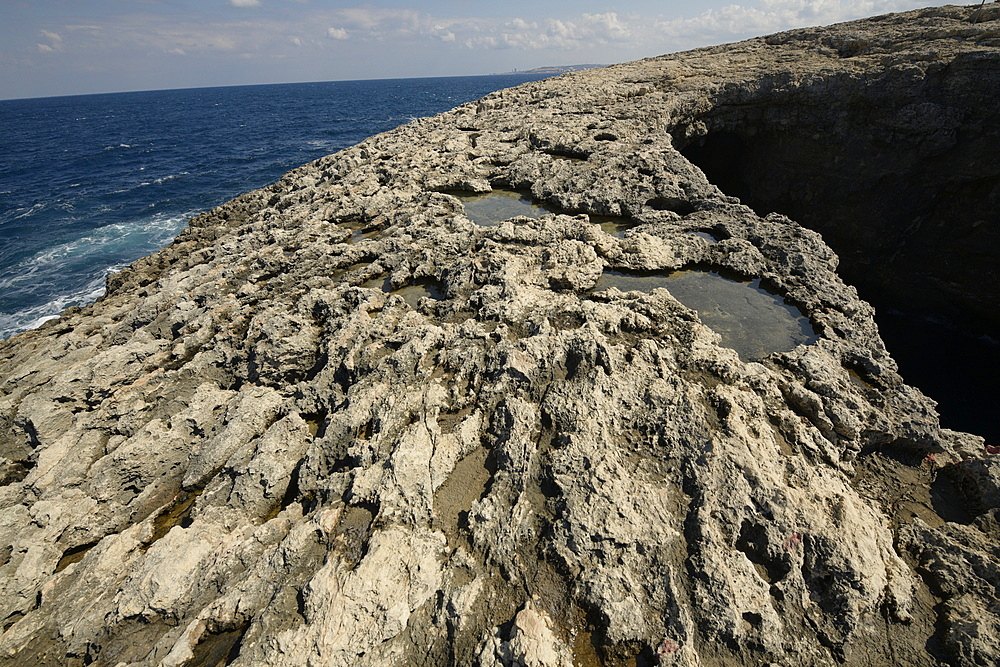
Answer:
[593,271,818,361]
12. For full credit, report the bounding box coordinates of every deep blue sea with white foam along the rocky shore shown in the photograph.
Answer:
[0,74,543,339]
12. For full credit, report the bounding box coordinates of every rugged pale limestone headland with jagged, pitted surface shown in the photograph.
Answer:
[0,7,1000,666]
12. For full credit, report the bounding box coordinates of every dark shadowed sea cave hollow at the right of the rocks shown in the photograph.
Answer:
[674,56,1000,444]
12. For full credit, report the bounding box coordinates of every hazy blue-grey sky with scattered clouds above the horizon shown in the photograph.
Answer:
[0,0,944,99]
